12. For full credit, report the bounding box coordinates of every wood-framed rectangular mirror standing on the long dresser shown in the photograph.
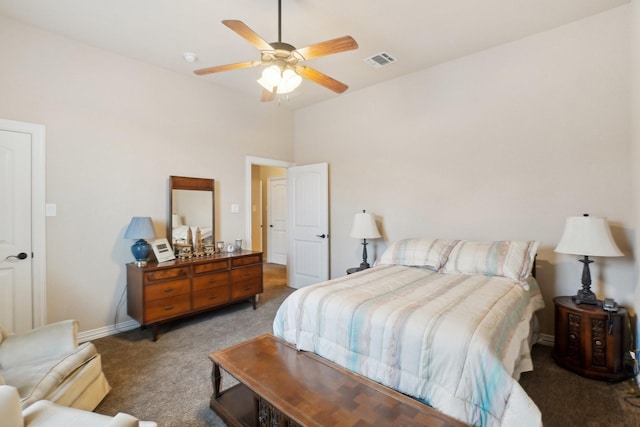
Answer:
[167,176,216,252]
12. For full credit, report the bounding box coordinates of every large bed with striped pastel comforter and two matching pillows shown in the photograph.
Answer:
[273,238,544,426]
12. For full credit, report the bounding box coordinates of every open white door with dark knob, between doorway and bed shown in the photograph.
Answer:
[287,163,329,288]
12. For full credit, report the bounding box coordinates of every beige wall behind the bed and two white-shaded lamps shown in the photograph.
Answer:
[295,6,637,335]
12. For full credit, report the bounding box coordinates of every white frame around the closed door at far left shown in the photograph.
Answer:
[0,119,47,328]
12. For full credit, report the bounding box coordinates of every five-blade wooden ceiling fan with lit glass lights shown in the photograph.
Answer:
[194,0,358,101]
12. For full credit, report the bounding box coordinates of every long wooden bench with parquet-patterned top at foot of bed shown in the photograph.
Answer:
[210,334,466,427]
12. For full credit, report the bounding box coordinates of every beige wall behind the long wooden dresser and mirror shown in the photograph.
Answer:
[0,17,293,331]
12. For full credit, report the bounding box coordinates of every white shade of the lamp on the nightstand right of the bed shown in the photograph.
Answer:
[555,216,624,257]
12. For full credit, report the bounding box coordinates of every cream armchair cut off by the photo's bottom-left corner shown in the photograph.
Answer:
[0,385,157,427]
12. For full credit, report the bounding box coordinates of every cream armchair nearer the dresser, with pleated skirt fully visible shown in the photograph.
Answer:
[0,320,111,411]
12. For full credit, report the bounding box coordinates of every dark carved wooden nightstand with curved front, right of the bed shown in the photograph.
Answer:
[553,297,628,380]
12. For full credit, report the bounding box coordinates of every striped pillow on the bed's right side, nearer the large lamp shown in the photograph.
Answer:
[441,240,540,281]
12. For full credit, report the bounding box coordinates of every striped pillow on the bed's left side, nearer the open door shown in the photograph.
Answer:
[375,238,457,271]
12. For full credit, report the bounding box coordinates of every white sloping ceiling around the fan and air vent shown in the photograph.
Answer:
[0,0,629,108]
